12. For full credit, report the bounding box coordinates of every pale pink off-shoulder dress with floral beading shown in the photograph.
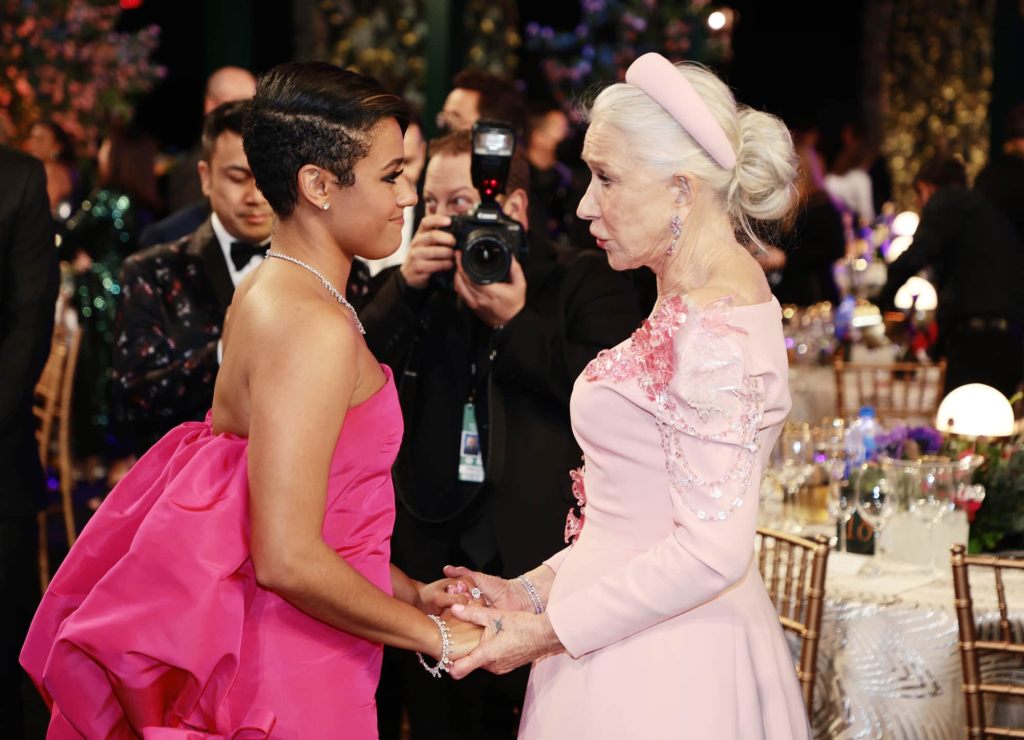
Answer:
[519,297,810,740]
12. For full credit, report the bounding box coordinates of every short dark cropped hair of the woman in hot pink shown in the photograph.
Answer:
[243,61,409,218]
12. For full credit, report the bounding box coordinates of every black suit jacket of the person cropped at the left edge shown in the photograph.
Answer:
[0,146,59,517]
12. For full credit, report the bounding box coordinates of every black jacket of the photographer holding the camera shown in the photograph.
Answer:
[360,236,641,579]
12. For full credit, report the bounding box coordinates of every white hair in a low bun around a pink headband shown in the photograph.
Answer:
[588,62,799,245]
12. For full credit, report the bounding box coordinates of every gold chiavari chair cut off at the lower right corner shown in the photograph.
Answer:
[951,545,1024,740]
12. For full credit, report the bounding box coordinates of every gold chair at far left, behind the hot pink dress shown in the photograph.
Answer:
[33,320,82,591]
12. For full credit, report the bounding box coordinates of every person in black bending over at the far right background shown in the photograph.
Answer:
[880,157,1024,396]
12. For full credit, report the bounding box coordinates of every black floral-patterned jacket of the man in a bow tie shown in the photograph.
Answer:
[114,219,370,452]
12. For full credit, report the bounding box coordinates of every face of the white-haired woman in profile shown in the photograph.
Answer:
[577,120,676,271]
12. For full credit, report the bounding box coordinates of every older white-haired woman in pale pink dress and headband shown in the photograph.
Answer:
[446,54,810,740]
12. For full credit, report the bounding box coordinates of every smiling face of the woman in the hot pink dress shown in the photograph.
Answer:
[324,118,416,260]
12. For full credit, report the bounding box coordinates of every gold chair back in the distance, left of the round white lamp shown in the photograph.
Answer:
[834,359,946,424]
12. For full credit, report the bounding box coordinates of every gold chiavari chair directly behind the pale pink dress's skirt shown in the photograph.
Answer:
[756,527,828,716]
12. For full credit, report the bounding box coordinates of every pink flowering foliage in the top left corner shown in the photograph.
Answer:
[0,0,166,155]
